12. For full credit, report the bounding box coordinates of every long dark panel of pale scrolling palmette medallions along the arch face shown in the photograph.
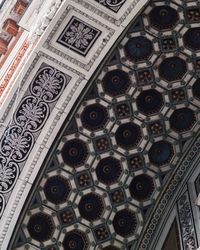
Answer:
[0,65,71,214]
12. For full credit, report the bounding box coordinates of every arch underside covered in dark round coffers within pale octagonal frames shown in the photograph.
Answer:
[9,0,200,250]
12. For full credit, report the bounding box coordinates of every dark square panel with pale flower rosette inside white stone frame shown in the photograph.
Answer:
[57,16,101,56]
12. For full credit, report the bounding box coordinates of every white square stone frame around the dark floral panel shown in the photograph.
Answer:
[43,5,115,71]
